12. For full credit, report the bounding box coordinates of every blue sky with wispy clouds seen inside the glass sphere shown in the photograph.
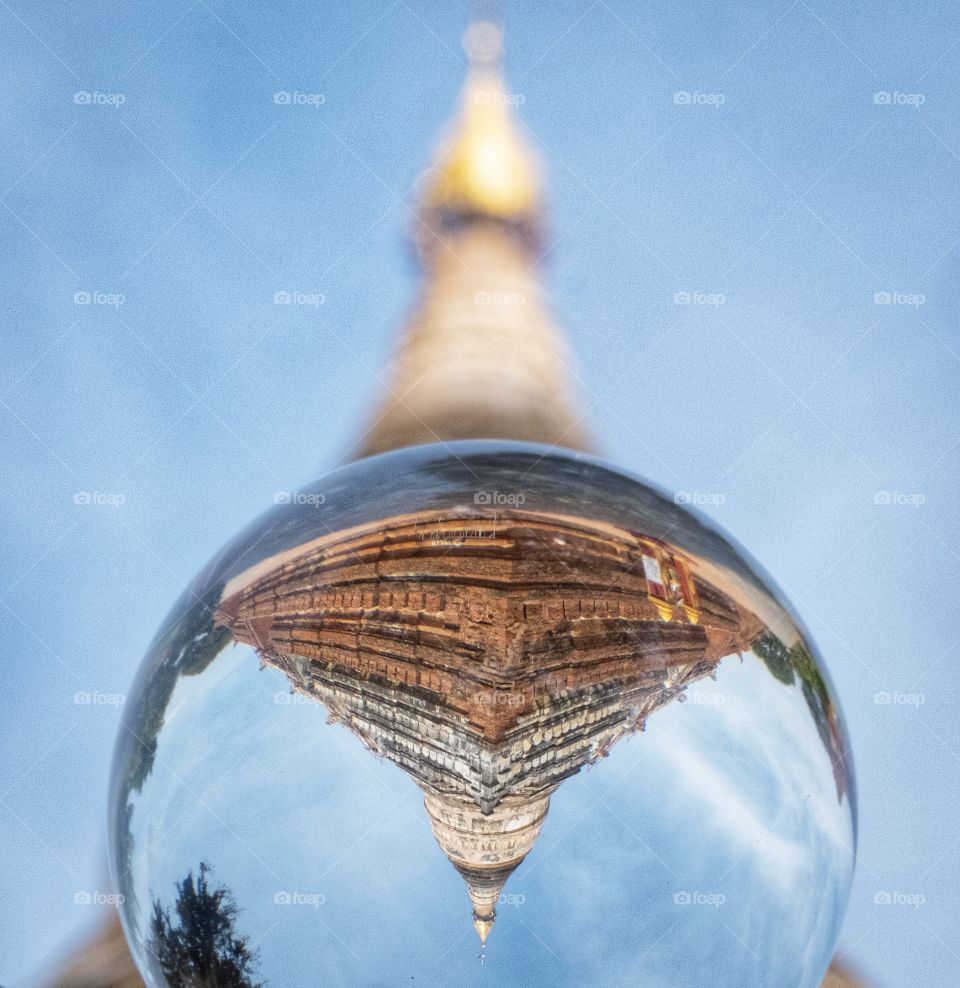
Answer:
[114,646,851,988]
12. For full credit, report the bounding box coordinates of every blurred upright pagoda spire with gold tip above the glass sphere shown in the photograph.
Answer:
[350,20,590,457]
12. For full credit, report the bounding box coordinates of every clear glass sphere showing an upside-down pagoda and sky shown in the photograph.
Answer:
[110,442,855,988]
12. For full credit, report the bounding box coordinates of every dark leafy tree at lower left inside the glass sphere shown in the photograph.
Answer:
[149,862,263,988]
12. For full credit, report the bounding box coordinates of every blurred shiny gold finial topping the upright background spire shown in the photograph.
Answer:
[424,21,540,234]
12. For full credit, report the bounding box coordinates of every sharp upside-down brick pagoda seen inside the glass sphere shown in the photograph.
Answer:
[215,509,764,940]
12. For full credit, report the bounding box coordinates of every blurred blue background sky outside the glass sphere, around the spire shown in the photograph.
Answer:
[0,0,960,985]
